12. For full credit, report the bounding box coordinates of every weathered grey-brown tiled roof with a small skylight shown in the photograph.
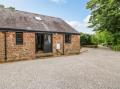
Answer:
[0,8,78,34]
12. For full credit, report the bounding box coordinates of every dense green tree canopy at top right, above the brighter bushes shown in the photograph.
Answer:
[87,0,120,33]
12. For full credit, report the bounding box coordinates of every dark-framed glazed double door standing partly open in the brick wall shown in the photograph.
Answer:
[36,33,52,53]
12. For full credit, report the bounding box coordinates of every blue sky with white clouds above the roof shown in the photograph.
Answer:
[0,0,93,34]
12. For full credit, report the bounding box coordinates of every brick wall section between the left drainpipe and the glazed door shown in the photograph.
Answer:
[7,32,35,61]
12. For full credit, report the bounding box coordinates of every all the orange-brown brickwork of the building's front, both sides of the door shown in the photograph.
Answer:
[0,32,80,61]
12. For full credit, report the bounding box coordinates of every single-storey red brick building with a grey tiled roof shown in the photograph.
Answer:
[0,8,80,62]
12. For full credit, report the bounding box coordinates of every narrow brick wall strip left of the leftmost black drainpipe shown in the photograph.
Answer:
[0,32,5,62]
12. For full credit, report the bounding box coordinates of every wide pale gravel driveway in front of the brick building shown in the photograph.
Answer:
[0,48,120,89]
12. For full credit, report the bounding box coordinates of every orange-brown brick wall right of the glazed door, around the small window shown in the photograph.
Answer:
[53,34,80,55]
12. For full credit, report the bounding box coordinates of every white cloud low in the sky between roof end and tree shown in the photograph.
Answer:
[67,15,94,34]
